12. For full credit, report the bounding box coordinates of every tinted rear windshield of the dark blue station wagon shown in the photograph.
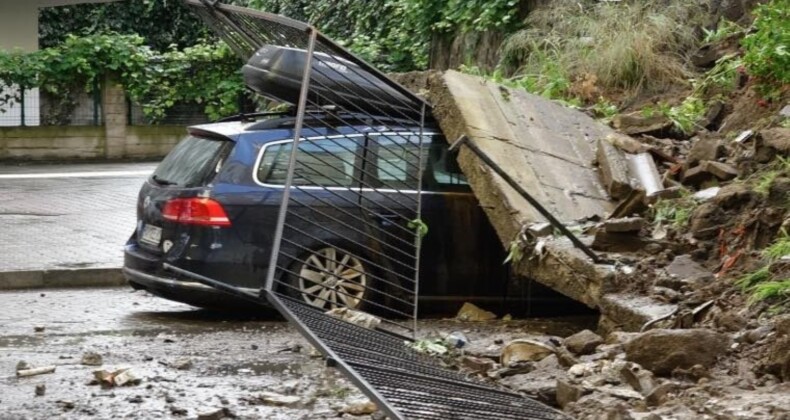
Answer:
[152,136,233,187]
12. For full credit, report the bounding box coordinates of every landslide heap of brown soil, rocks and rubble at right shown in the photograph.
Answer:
[398,1,790,420]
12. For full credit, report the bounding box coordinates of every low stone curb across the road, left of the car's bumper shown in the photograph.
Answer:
[0,267,127,290]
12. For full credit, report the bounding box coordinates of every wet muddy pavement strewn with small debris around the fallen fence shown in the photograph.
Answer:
[0,288,595,420]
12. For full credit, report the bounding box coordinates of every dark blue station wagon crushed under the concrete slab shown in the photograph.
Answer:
[123,114,508,309]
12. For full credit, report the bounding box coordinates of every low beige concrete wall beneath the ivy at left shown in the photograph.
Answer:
[0,126,186,162]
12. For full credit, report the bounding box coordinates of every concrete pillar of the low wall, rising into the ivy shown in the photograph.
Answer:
[101,74,128,159]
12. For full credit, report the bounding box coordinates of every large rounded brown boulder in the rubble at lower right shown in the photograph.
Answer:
[623,328,729,376]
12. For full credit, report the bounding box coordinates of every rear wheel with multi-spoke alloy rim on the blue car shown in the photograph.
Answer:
[288,246,373,310]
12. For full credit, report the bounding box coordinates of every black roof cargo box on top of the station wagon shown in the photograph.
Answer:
[242,45,422,118]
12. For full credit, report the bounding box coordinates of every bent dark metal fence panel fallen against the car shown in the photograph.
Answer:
[182,0,564,419]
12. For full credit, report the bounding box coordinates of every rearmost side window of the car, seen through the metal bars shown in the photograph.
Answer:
[256,138,358,187]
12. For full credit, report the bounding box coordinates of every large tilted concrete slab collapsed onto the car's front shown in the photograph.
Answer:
[420,71,680,330]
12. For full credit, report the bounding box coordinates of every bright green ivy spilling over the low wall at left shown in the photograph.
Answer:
[0,34,244,120]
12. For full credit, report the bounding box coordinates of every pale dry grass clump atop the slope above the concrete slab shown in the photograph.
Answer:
[501,0,705,99]
